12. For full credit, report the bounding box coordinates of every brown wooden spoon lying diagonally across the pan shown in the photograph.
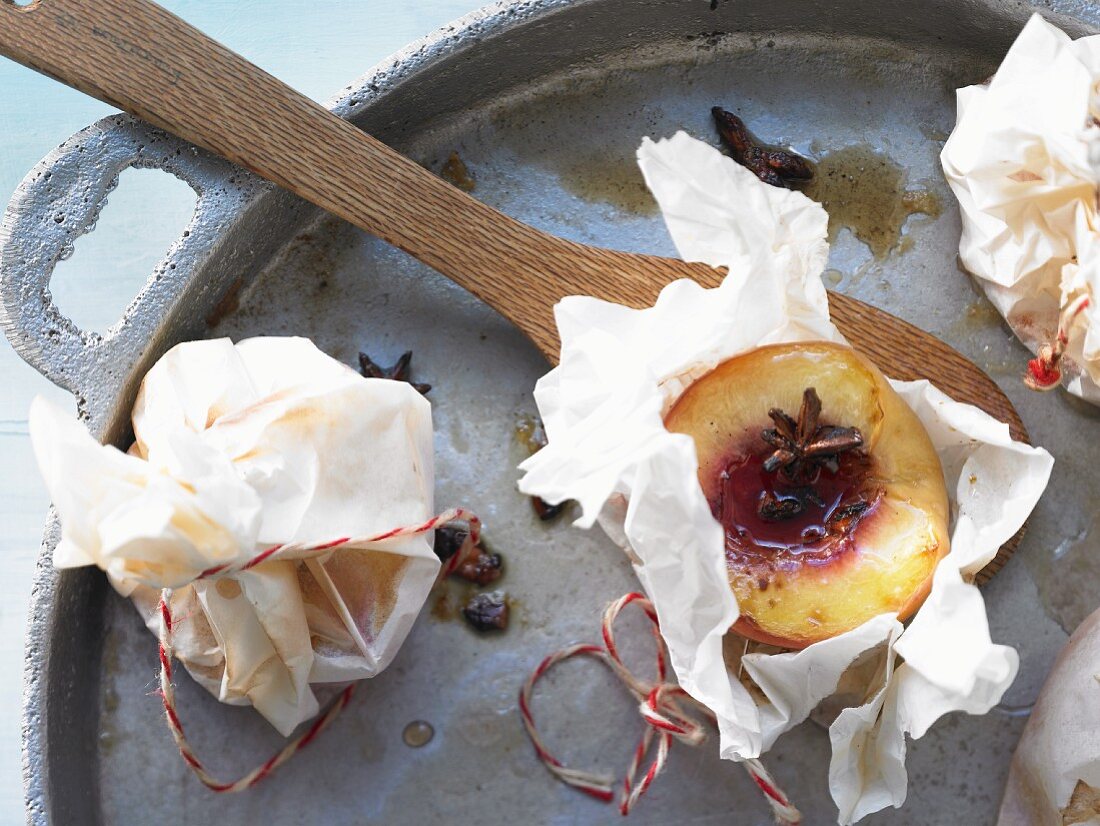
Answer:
[0,0,1027,575]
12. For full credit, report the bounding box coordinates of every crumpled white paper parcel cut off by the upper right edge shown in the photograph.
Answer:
[941,14,1100,404]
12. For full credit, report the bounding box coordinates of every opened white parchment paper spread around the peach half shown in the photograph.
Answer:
[520,133,1053,823]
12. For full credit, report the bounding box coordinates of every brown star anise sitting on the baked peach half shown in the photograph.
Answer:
[760,387,864,483]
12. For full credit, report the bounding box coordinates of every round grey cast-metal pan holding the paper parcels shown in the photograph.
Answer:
[8,0,1100,826]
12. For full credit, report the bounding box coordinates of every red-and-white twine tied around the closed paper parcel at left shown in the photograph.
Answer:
[157,508,481,792]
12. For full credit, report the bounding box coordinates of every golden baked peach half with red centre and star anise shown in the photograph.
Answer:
[664,342,948,649]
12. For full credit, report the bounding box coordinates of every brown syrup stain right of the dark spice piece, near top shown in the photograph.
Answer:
[803,144,942,260]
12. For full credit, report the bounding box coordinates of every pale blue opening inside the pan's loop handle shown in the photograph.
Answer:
[47,167,197,333]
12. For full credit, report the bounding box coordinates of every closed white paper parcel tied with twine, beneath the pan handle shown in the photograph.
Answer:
[30,338,439,735]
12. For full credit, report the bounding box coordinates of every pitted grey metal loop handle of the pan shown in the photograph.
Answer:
[0,115,247,415]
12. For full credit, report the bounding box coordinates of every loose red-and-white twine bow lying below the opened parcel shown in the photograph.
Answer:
[519,593,802,826]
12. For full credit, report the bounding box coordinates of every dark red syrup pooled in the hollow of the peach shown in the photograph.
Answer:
[711,452,882,582]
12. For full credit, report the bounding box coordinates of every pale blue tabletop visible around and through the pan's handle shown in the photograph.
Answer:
[0,0,476,824]
